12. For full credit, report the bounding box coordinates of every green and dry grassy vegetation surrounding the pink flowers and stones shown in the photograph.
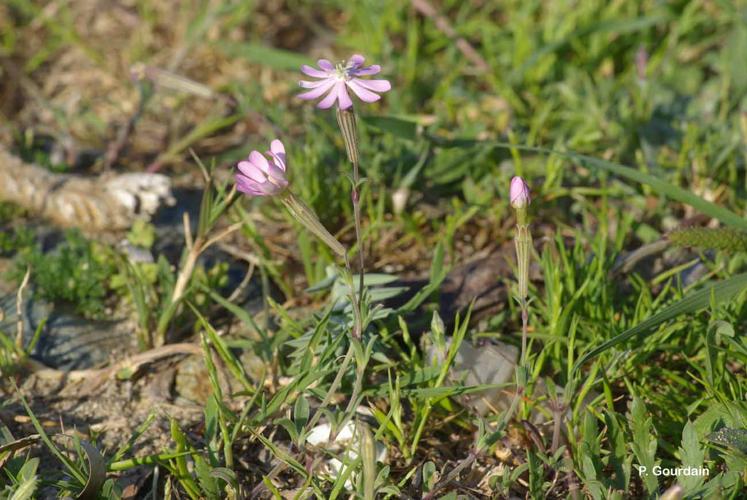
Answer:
[0,0,747,498]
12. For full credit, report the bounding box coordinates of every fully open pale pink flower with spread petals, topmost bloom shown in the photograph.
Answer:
[298,54,392,109]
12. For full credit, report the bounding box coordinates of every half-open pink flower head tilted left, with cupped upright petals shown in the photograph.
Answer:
[236,139,288,196]
